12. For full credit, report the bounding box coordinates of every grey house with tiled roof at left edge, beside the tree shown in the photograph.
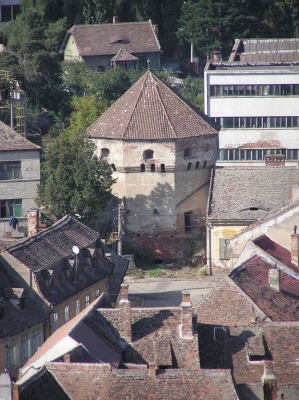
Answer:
[0,121,41,238]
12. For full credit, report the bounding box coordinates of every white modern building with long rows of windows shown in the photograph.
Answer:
[204,39,299,165]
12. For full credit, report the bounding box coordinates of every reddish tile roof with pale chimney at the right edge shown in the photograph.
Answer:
[229,255,299,321]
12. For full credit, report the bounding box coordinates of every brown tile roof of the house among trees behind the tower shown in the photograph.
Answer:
[62,21,161,57]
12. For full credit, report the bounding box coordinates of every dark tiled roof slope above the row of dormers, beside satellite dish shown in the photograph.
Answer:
[6,215,99,272]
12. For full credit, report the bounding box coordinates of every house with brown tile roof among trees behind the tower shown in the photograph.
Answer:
[61,18,161,72]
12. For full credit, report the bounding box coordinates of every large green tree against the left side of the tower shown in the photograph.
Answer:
[36,132,115,219]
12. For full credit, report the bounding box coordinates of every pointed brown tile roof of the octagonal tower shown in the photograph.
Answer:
[87,71,220,140]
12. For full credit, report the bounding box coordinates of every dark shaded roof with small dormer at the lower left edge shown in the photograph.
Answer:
[0,264,49,339]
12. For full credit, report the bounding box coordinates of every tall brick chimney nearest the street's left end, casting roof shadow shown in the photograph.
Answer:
[119,283,132,343]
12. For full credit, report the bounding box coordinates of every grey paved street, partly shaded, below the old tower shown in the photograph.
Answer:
[125,275,224,307]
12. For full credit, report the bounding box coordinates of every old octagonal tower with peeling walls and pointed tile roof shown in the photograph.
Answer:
[87,71,219,258]
